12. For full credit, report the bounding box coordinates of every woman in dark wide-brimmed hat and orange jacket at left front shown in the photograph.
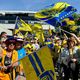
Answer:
[0,37,18,80]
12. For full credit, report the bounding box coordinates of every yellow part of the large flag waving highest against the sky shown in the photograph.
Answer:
[35,2,70,19]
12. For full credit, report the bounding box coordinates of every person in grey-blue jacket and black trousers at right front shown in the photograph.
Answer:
[60,38,80,80]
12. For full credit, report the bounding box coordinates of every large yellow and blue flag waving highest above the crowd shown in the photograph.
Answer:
[35,4,76,26]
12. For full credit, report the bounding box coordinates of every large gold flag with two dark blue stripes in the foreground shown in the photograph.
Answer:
[21,46,56,80]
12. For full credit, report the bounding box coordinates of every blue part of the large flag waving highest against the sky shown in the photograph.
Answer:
[44,6,77,26]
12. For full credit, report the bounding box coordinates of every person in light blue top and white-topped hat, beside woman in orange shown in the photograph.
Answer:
[16,38,26,75]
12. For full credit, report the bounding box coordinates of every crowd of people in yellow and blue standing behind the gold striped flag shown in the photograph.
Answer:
[0,32,80,80]
